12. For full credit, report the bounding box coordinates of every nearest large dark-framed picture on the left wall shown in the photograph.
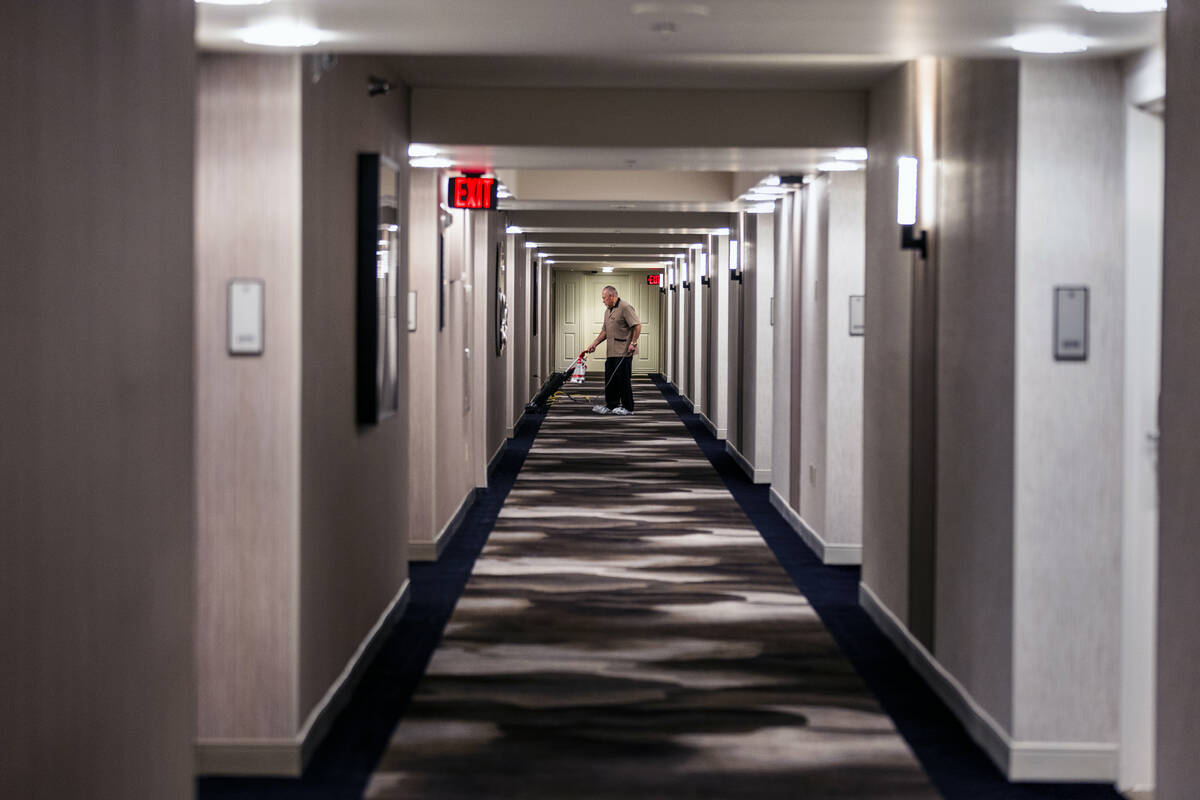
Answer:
[355,152,403,425]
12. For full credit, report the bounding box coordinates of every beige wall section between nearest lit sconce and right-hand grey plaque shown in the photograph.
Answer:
[931,60,1017,730]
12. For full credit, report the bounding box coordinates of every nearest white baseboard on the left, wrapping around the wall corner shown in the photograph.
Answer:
[194,578,412,777]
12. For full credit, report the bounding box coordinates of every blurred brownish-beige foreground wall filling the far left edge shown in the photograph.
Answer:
[0,0,194,800]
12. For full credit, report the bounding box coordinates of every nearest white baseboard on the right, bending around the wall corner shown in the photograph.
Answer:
[858,583,1117,781]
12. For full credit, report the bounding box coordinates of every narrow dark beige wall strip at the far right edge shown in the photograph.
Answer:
[1156,0,1200,800]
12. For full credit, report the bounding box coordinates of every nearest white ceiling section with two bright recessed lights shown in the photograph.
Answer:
[197,0,1162,89]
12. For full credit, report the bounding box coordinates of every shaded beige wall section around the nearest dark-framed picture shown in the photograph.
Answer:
[299,56,408,721]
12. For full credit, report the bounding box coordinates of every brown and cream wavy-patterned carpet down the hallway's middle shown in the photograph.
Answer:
[366,378,938,800]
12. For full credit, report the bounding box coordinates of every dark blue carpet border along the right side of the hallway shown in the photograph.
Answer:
[652,375,1122,800]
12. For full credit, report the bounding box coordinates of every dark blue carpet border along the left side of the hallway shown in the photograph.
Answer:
[196,413,546,800]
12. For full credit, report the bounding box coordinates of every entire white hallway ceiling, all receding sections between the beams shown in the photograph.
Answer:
[197,0,1163,275]
